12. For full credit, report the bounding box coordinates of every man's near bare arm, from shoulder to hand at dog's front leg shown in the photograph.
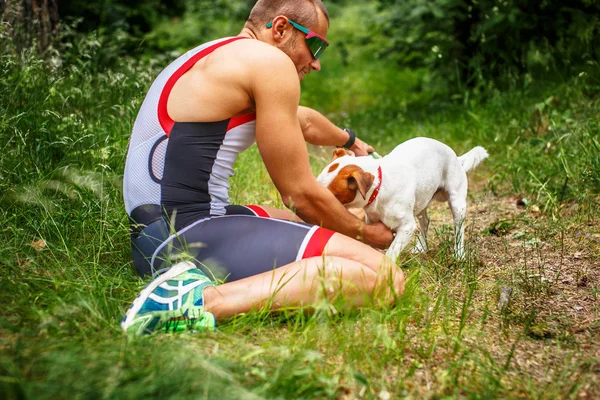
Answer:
[251,48,393,248]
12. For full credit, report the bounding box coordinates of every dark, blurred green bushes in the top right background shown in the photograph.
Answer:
[373,0,600,92]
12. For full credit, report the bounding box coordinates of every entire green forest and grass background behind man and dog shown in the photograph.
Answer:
[0,0,600,399]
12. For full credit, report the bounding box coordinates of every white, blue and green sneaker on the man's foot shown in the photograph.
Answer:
[121,262,216,336]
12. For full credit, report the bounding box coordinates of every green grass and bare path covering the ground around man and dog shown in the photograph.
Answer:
[0,6,600,399]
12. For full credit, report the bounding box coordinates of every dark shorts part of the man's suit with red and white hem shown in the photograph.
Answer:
[130,205,334,282]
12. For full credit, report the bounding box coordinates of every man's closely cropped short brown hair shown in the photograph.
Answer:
[246,0,329,29]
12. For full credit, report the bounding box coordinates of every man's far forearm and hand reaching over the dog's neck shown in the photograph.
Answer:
[298,106,374,156]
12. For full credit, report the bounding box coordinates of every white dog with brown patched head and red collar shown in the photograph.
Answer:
[317,138,488,260]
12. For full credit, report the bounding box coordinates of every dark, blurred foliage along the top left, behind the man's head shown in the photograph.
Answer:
[0,0,252,70]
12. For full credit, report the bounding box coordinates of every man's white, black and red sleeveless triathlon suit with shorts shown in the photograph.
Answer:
[123,37,334,281]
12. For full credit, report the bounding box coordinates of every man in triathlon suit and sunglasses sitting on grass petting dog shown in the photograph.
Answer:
[121,0,404,335]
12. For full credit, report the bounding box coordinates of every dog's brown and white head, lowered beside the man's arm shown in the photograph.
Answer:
[317,149,375,207]
